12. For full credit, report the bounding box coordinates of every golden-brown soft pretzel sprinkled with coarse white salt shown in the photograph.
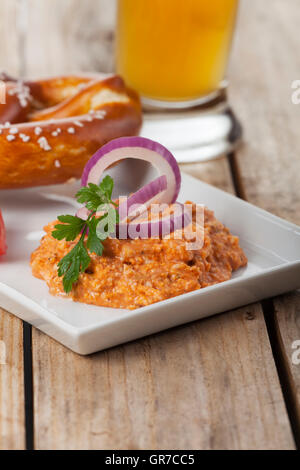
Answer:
[0,74,142,189]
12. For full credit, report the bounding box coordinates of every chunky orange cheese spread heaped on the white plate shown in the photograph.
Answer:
[31,205,247,309]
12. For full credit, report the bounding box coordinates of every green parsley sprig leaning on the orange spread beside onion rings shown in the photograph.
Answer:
[52,176,119,293]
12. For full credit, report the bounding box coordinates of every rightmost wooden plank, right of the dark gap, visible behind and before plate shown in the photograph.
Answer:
[231,0,300,439]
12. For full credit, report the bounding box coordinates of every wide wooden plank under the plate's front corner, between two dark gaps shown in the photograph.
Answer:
[33,305,293,449]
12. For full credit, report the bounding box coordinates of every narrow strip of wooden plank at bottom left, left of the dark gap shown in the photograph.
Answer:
[0,309,25,450]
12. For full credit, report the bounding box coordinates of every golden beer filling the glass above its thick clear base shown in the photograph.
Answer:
[116,0,238,108]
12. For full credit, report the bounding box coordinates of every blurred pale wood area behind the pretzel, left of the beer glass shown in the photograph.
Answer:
[0,0,116,77]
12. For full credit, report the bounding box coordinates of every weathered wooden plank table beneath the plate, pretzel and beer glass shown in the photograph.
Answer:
[0,0,300,449]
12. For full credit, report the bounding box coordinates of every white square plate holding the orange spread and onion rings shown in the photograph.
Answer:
[0,174,300,354]
